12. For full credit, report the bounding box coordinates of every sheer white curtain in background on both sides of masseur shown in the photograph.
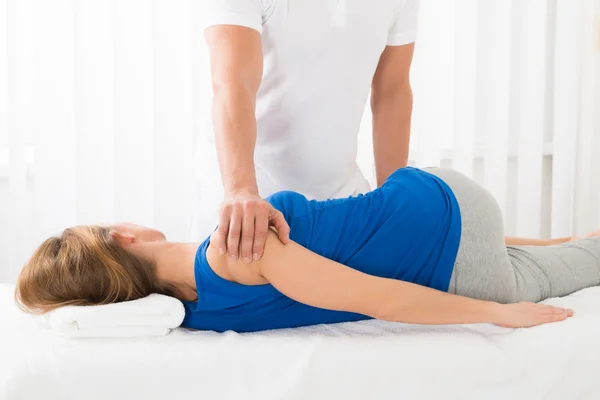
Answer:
[0,0,600,282]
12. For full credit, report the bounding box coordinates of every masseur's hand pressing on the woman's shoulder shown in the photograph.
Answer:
[211,190,290,264]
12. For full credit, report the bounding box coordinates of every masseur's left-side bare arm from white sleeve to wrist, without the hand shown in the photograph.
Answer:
[205,25,263,196]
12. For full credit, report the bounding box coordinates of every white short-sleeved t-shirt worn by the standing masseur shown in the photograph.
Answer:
[192,0,418,238]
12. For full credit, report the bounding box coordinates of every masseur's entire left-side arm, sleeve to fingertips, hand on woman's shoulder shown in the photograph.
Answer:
[206,25,289,263]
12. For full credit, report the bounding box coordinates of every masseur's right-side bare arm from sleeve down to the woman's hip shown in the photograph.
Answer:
[371,43,415,186]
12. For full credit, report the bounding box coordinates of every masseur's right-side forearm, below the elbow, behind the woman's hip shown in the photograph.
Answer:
[371,83,413,186]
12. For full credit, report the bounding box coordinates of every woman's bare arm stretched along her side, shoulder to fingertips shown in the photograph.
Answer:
[207,232,572,327]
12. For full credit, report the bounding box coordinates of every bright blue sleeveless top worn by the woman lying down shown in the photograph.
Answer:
[183,168,461,332]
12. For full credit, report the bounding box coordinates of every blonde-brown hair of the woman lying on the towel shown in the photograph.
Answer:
[15,226,176,313]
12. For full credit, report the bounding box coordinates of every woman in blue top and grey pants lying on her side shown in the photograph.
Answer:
[16,168,600,332]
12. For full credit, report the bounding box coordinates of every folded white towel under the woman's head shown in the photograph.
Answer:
[46,294,185,338]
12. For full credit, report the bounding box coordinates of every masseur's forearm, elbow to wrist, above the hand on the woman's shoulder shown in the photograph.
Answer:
[213,84,258,193]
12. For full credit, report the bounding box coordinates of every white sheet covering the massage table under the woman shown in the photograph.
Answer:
[0,285,600,400]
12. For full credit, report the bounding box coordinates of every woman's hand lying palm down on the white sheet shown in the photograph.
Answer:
[494,303,574,328]
